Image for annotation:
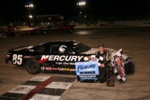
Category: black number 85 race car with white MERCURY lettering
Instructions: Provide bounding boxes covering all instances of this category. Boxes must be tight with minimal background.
[5,40,134,74]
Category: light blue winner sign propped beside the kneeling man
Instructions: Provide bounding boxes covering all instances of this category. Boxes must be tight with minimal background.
[75,61,99,82]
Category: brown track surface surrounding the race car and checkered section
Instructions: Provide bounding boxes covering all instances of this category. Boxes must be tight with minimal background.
[0,26,150,100]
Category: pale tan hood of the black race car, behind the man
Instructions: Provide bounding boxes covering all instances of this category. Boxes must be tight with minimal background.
[81,48,128,59]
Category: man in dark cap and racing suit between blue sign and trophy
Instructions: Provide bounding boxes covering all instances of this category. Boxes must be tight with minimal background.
[96,44,111,83]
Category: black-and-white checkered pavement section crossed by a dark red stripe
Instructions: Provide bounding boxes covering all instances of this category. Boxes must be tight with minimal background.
[0,76,76,100]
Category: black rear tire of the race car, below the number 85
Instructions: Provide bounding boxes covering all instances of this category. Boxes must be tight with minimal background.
[24,59,41,74]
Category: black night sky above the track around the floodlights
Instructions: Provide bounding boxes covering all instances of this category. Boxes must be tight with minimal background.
[0,0,150,20]
